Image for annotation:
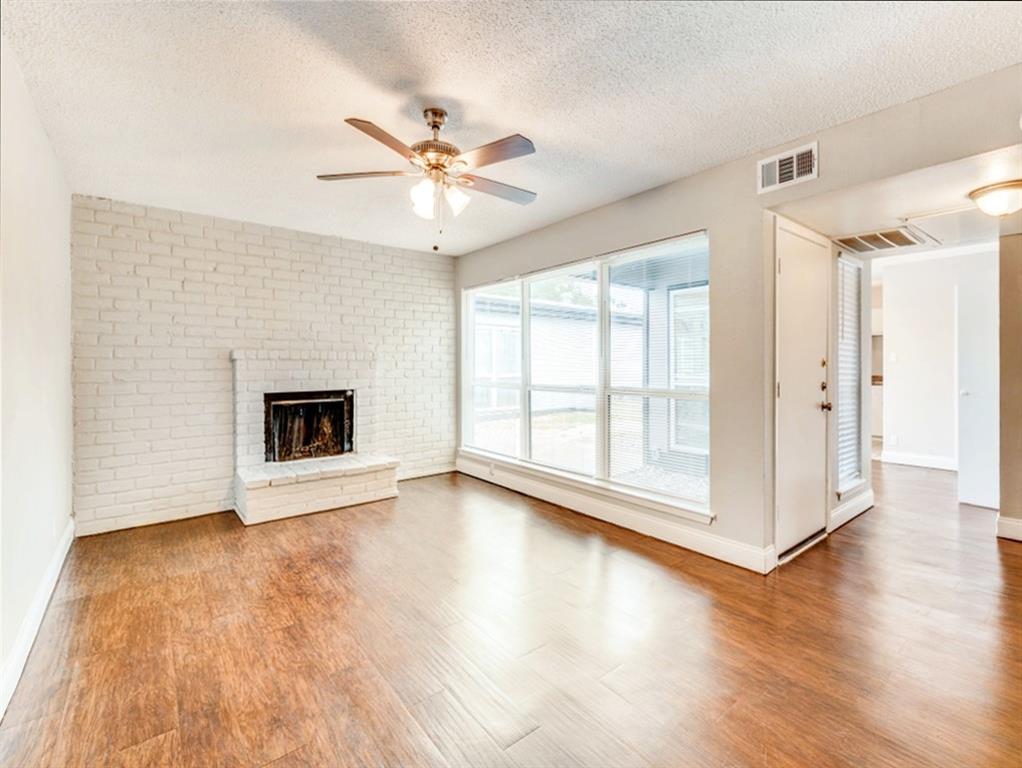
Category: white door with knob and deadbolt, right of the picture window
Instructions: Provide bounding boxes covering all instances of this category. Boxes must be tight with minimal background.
[775,217,832,554]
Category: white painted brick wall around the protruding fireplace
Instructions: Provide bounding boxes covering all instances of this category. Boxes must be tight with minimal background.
[72,195,456,531]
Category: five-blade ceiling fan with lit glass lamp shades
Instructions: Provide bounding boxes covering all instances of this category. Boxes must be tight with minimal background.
[316,106,536,232]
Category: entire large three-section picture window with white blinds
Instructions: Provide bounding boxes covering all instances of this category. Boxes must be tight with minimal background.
[462,233,710,506]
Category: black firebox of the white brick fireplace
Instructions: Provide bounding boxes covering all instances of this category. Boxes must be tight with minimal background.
[263,390,355,461]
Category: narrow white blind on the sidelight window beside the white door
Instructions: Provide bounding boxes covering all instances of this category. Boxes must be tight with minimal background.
[837,256,863,491]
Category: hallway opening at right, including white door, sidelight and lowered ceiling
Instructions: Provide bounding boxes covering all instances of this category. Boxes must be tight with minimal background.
[772,144,1022,562]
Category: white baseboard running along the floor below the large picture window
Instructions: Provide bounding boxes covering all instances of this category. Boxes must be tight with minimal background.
[458,454,777,574]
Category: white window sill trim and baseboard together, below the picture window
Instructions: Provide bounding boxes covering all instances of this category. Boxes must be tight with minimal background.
[458,449,777,574]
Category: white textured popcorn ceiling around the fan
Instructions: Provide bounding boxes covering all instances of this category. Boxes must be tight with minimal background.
[2,0,1022,254]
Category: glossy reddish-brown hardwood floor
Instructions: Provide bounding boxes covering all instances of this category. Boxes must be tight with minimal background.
[0,464,1022,768]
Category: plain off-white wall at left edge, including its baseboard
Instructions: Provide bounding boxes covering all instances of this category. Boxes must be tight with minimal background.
[0,38,72,712]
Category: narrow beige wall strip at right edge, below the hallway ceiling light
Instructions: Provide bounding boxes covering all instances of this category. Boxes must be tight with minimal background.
[1001,224,1022,518]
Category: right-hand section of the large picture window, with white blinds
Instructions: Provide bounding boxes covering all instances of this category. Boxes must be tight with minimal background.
[607,240,709,504]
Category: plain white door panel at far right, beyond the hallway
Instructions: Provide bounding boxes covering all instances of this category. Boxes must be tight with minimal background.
[957,254,1001,509]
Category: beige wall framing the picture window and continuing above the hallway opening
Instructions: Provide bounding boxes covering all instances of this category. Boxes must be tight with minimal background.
[458,65,1022,546]
